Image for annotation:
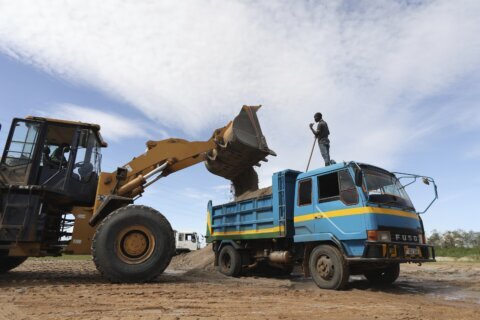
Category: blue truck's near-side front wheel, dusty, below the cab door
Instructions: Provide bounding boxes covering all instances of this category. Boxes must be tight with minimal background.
[308,245,350,290]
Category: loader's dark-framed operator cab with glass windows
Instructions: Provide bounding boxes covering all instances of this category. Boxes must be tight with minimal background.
[0,117,106,207]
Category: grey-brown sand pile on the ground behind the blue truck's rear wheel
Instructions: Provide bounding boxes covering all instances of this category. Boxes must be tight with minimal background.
[168,245,215,271]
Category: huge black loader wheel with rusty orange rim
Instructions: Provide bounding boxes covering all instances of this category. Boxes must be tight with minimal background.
[92,205,175,283]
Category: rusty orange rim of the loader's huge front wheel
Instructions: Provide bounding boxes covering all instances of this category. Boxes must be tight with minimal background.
[116,225,155,264]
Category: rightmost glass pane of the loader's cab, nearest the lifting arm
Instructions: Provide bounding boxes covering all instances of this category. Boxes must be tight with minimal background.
[72,129,101,183]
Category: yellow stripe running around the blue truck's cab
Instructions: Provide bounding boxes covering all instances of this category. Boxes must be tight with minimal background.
[293,207,418,222]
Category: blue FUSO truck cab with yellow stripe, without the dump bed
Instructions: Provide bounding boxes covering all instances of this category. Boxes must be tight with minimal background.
[294,162,434,263]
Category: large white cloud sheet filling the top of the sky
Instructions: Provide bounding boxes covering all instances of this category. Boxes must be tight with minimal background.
[0,0,480,181]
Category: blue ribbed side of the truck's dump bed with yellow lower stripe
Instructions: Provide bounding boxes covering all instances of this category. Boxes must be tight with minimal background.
[207,170,298,242]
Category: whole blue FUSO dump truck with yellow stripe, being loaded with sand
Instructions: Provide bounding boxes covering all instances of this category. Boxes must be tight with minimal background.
[207,162,438,290]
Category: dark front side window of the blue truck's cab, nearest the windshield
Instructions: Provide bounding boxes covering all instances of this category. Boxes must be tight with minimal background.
[317,170,358,205]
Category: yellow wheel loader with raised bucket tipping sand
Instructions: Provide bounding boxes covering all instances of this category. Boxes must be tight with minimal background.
[0,106,275,282]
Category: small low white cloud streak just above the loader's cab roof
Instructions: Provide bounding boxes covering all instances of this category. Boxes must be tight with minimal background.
[46,104,149,141]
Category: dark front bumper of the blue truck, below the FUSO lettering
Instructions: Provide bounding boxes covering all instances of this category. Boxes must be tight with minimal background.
[347,241,435,263]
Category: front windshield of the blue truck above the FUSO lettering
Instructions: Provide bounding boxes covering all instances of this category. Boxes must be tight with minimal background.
[364,169,415,210]
